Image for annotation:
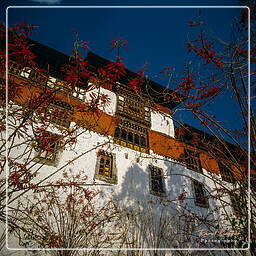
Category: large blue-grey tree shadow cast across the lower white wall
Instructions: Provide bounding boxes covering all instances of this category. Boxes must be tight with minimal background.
[110,161,232,250]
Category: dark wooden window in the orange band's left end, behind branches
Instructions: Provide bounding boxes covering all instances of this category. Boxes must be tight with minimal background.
[47,100,73,128]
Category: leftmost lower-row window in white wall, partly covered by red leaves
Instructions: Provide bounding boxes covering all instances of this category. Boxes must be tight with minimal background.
[33,131,61,166]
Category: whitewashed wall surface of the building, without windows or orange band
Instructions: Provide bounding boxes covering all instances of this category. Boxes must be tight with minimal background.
[3,88,236,252]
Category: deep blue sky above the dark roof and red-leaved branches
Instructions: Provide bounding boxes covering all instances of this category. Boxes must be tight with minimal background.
[0,0,248,144]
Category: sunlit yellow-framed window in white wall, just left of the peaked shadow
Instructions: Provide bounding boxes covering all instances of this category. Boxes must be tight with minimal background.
[95,150,117,184]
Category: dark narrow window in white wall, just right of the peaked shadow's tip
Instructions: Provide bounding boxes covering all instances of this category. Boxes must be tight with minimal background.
[149,165,166,196]
